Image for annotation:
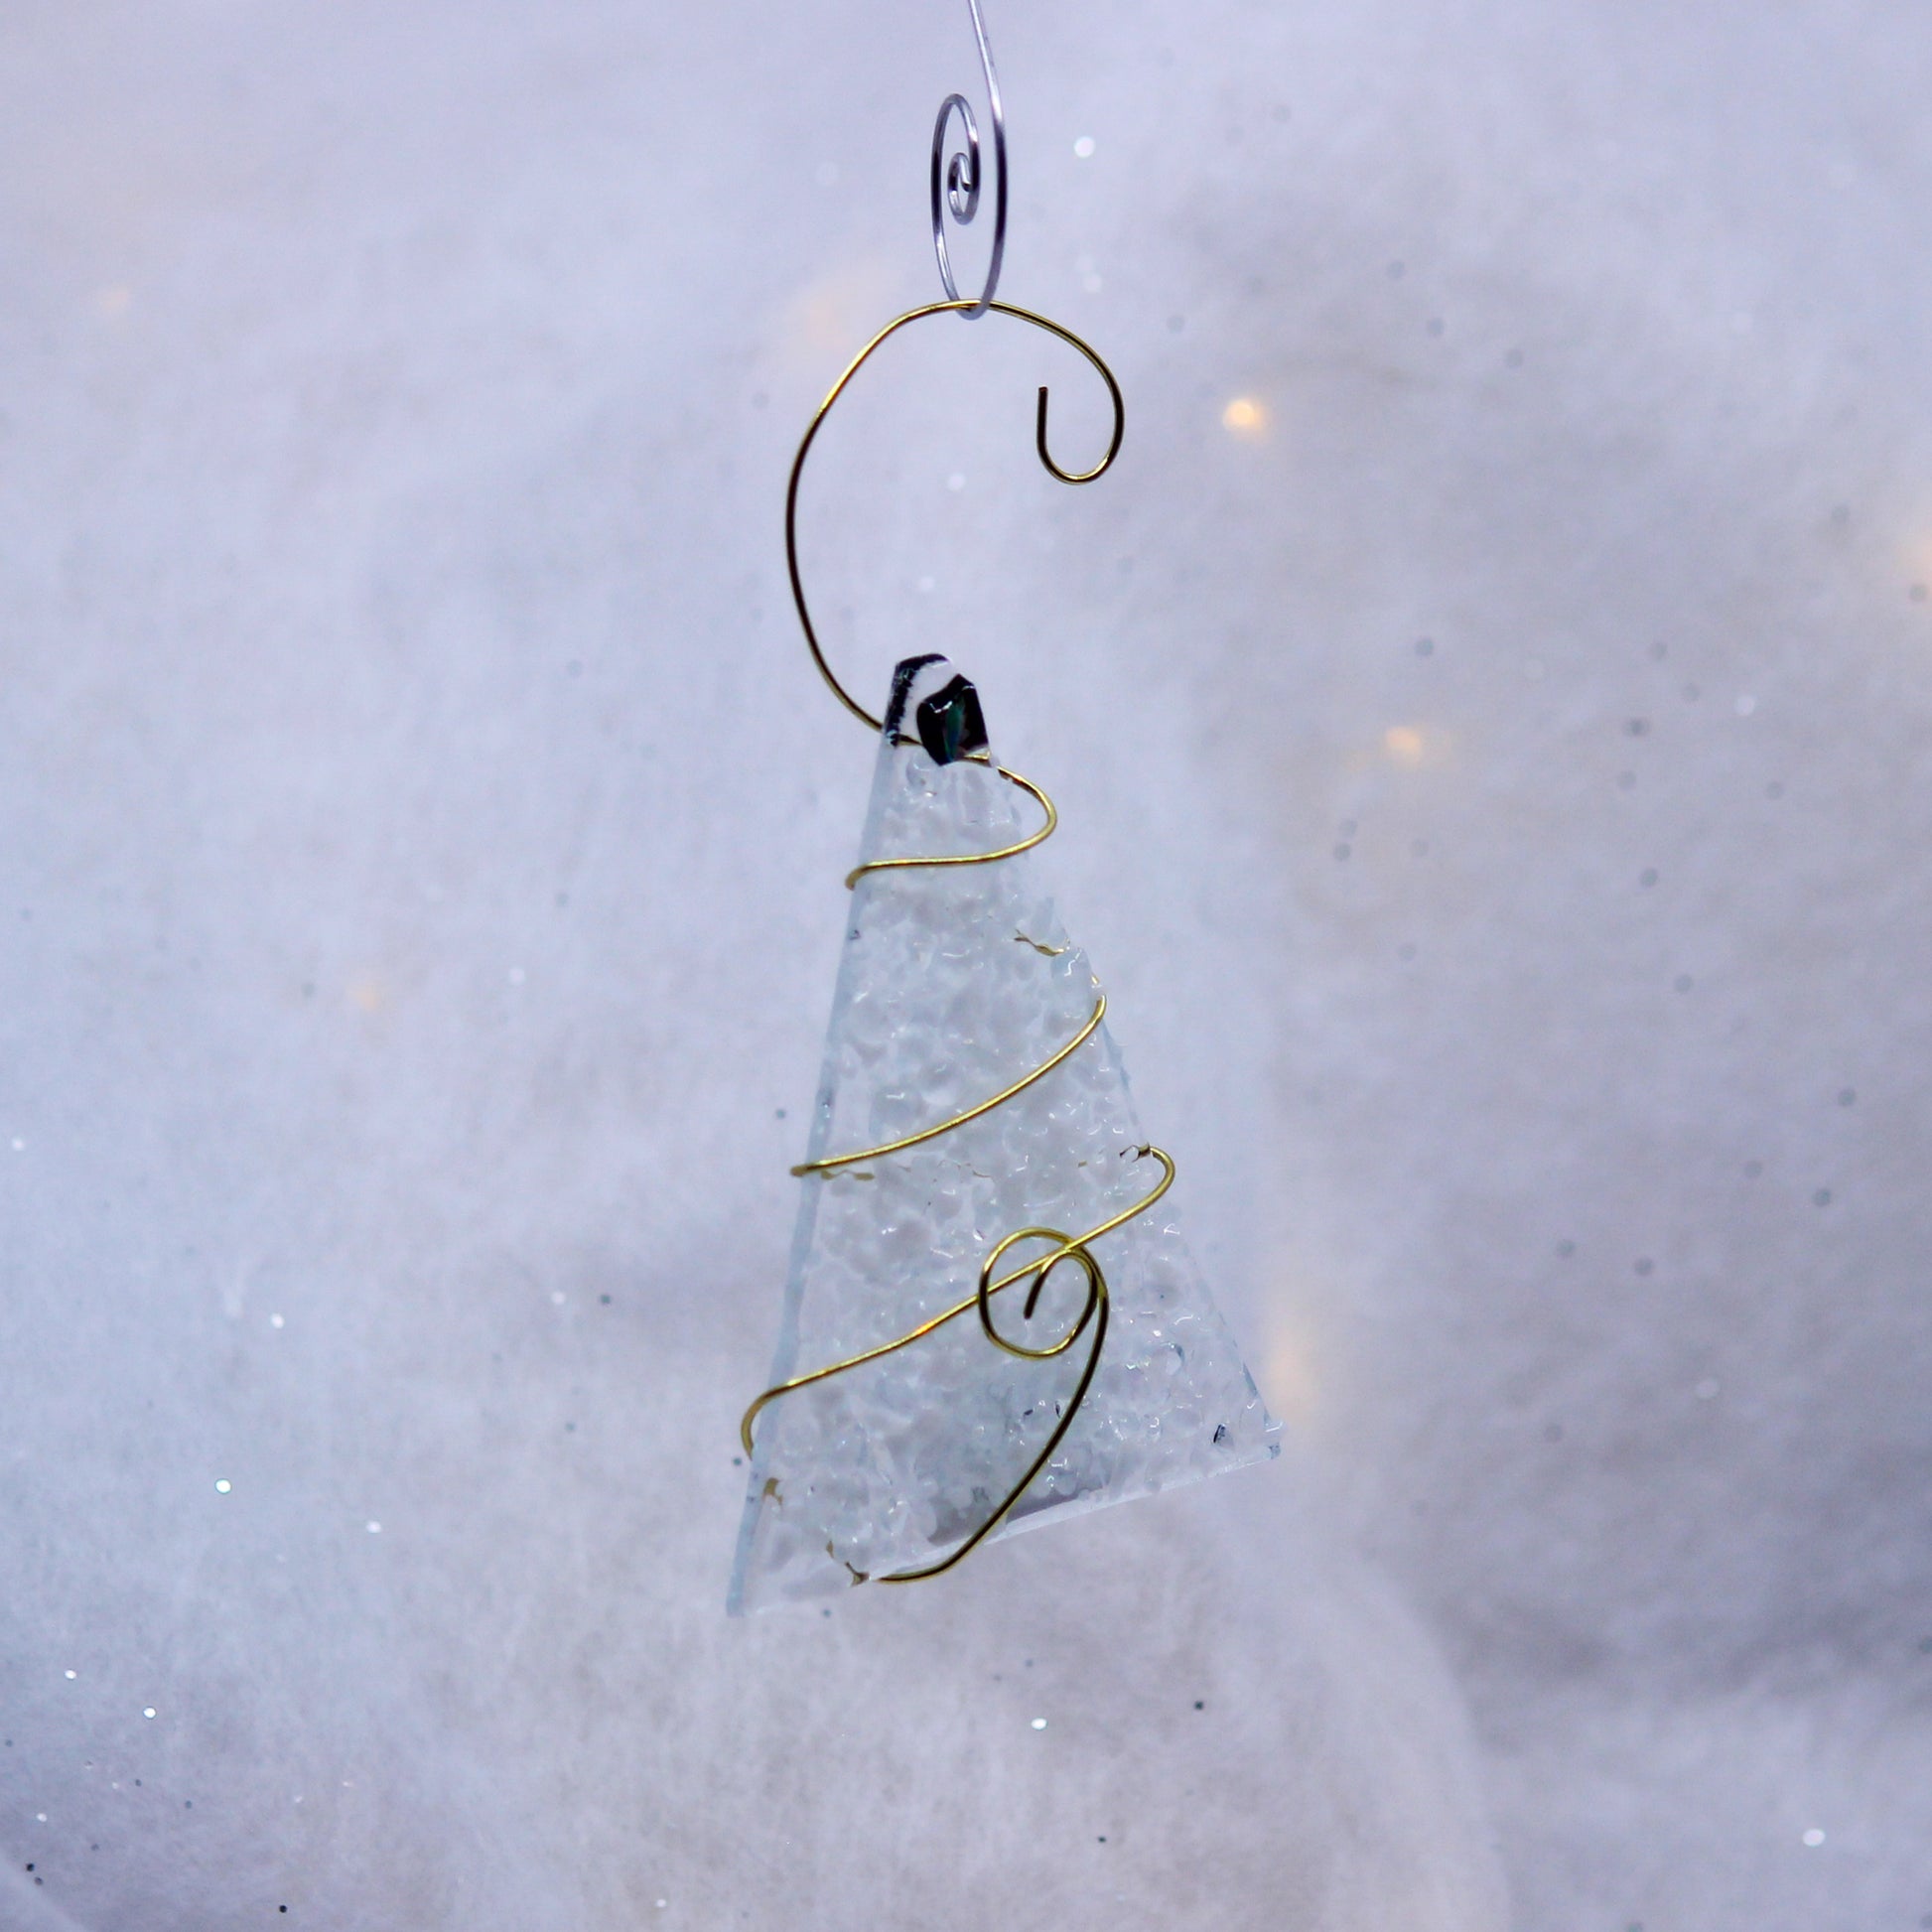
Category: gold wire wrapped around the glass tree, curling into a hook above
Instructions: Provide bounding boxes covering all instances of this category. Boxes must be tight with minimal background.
[738,289,1174,1583]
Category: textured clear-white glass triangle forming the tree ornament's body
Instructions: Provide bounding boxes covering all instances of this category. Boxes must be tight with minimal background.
[731,659,1279,1611]
